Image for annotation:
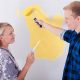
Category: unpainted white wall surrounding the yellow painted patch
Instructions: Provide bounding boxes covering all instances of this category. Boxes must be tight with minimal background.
[0,0,79,80]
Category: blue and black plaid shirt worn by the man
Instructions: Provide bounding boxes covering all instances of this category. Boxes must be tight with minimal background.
[62,30,80,80]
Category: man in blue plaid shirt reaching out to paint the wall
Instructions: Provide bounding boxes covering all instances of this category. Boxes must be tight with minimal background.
[37,1,80,80]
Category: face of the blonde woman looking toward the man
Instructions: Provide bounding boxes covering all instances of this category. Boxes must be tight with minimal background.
[1,26,15,44]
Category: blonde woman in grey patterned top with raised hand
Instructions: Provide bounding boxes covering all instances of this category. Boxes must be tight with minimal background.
[0,23,34,80]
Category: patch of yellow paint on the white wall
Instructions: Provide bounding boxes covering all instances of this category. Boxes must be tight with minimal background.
[24,6,64,60]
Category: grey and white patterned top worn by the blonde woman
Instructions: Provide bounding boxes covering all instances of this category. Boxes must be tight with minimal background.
[0,48,20,80]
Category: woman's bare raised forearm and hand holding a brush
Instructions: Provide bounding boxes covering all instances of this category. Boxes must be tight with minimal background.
[17,52,34,80]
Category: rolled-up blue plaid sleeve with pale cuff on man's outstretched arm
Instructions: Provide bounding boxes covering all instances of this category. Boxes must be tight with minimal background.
[61,30,73,43]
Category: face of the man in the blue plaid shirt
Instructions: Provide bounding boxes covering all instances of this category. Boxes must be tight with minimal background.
[64,10,77,30]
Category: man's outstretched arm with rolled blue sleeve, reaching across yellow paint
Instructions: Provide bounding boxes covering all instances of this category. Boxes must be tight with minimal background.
[36,19,74,43]
